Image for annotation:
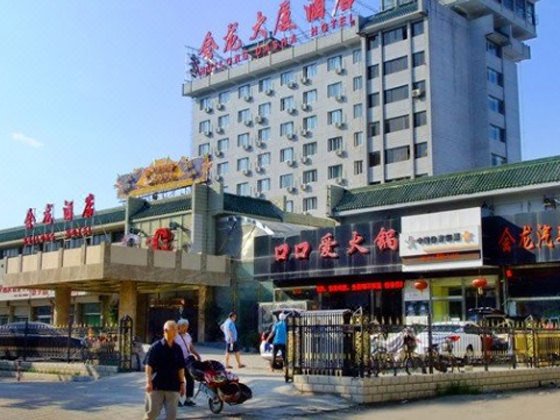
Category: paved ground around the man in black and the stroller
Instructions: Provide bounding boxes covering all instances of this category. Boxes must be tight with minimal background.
[0,346,352,420]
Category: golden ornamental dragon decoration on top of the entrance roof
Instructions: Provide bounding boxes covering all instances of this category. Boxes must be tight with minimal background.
[115,155,212,199]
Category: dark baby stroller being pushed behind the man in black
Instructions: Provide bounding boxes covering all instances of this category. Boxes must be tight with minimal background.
[187,360,253,414]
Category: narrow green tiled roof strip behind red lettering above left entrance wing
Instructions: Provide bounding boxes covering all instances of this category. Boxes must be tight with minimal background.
[0,207,125,243]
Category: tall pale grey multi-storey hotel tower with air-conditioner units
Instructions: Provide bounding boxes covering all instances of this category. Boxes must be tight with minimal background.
[183,0,537,216]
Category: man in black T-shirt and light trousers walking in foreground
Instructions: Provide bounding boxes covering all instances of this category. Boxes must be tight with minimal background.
[144,321,185,420]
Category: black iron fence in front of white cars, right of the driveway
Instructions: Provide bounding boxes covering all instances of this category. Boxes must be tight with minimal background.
[285,310,560,381]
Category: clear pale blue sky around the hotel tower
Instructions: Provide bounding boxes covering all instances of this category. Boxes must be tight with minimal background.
[0,0,560,229]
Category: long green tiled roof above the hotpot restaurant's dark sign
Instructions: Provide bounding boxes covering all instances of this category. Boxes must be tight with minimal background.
[334,156,560,213]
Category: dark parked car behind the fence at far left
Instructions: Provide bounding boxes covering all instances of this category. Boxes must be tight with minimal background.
[0,321,86,360]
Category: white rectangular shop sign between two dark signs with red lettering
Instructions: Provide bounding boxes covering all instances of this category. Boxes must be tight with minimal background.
[400,207,482,271]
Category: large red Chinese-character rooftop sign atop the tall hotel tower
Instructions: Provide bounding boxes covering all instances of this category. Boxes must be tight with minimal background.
[189,0,356,77]
